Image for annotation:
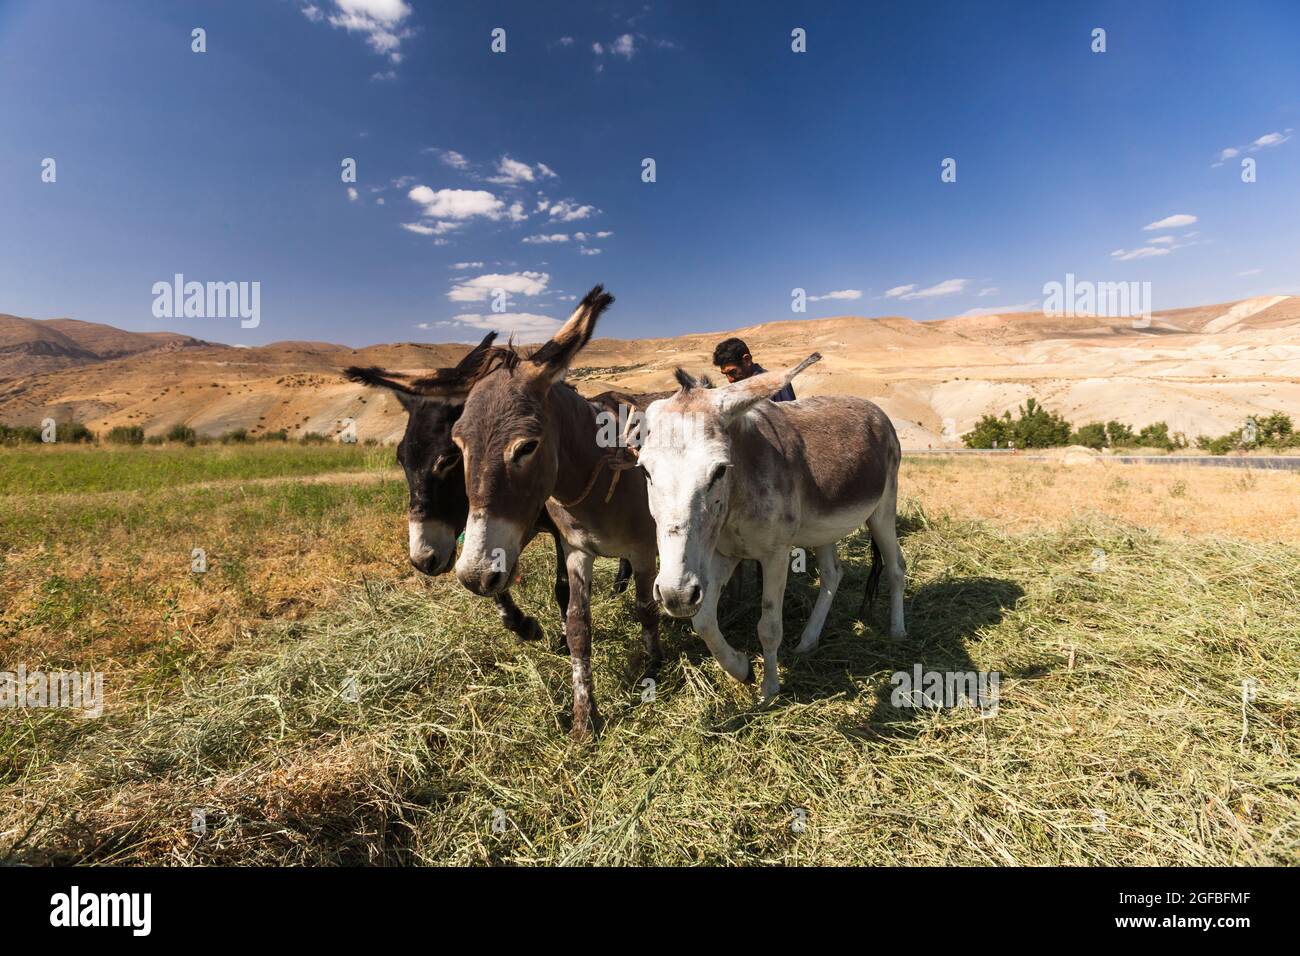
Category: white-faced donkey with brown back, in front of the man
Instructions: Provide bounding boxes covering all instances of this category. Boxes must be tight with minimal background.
[638,354,906,697]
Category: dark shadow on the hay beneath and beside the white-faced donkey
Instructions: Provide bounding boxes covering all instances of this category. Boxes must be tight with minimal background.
[644,515,1028,739]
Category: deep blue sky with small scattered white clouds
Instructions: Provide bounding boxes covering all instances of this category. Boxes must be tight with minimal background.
[0,0,1300,346]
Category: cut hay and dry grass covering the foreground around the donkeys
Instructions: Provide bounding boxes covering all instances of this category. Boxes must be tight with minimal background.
[0,447,1300,865]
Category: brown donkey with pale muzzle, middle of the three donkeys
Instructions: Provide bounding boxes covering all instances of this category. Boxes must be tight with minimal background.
[379,286,662,739]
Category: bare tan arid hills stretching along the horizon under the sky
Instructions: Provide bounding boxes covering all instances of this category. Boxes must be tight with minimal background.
[0,295,1300,449]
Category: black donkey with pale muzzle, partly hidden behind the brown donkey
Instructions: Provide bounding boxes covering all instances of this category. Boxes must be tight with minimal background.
[345,332,632,640]
